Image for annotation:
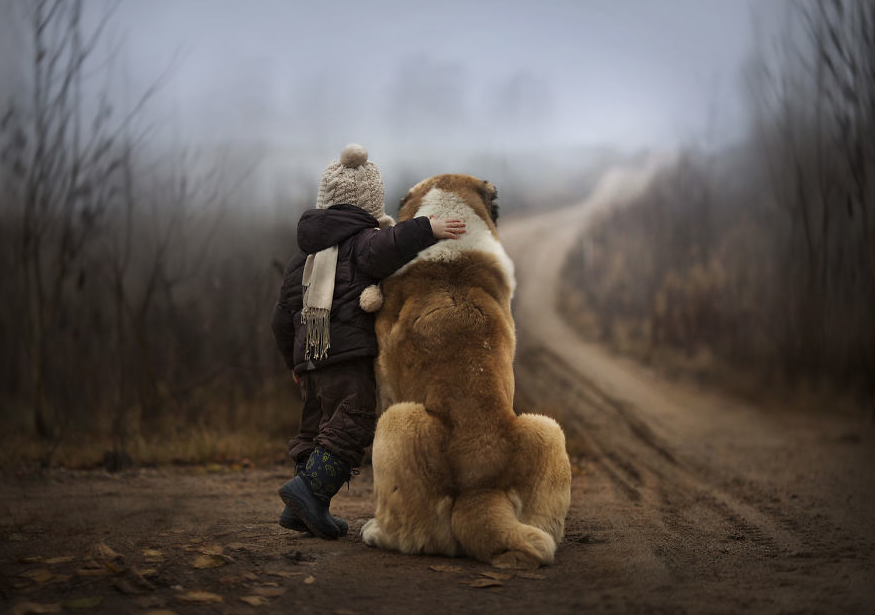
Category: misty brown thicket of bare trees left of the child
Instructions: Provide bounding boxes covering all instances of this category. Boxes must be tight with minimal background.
[0,0,306,462]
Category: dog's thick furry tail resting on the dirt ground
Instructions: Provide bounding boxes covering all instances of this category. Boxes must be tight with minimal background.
[452,489,556,569]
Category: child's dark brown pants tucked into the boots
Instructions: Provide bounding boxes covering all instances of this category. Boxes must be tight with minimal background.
[289,357,377,467]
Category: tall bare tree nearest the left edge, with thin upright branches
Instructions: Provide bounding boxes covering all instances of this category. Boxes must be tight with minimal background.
[10,0,126,437]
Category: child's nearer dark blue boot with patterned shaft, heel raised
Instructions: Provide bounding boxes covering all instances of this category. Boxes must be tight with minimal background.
[279,446,351,539]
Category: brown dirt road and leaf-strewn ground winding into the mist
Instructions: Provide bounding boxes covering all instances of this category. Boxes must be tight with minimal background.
[0,168,875,615]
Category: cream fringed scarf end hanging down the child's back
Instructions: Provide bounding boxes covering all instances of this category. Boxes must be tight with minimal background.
[301,246,337,361]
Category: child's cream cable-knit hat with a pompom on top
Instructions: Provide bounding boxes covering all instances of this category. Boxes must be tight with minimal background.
[316,143,393,227]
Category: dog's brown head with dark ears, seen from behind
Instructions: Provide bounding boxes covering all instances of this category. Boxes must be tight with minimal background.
[398,174,498,236]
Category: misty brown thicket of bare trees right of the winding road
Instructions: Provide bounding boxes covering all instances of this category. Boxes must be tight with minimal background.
[564,0,875,400]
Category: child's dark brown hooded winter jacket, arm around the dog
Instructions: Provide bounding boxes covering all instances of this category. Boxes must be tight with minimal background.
[272,205,437,374]
